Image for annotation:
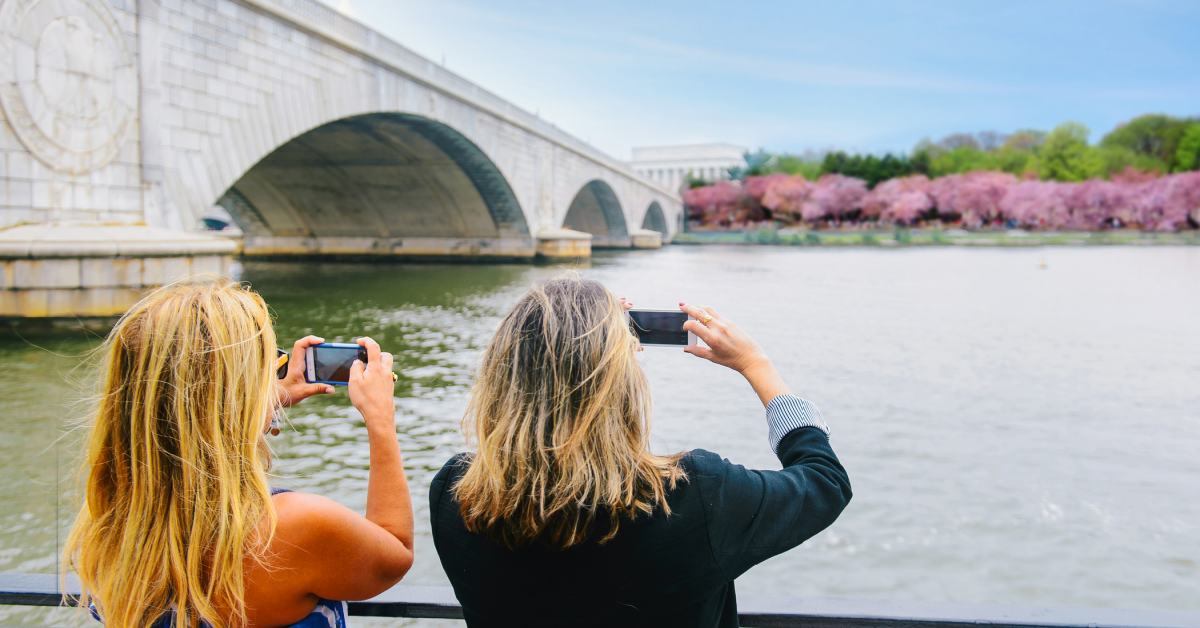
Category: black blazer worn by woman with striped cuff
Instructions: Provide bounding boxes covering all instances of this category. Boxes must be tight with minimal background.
[430,427,851,628]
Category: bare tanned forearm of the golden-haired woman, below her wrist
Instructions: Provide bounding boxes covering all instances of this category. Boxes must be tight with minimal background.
[367,425,413,550]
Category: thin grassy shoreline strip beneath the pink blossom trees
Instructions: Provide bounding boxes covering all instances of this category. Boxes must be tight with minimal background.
[671,229,1200,249]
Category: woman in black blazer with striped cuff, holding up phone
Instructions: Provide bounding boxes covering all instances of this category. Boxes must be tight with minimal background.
[430,275,851,628]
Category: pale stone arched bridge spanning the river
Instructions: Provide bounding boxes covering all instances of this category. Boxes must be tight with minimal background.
[0,0,683,262]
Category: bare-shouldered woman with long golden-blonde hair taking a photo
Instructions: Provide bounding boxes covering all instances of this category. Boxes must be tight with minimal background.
[65,280,413,628]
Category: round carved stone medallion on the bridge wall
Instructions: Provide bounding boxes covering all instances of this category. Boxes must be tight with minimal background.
[0,0,137,174]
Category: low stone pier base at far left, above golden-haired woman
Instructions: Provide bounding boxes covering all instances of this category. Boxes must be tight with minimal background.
[0,223,236,331]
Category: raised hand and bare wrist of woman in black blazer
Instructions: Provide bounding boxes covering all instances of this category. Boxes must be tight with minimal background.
[679,303,788,406]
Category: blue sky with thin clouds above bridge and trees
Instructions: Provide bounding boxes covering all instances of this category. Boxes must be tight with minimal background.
[326,0,1200,159]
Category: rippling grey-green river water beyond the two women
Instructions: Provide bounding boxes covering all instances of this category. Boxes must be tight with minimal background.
[0,246,1200,626]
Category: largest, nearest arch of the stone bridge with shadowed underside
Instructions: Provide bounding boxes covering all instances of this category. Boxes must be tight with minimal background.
[220,113,532,256]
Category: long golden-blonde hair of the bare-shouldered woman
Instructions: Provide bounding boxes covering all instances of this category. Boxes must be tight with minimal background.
[64,279,278,628]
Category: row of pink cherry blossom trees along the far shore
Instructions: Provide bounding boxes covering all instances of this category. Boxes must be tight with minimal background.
[684,169,1200,231]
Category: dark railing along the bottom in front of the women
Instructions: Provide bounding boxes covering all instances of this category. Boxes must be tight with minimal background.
[0,573,1200,628]
